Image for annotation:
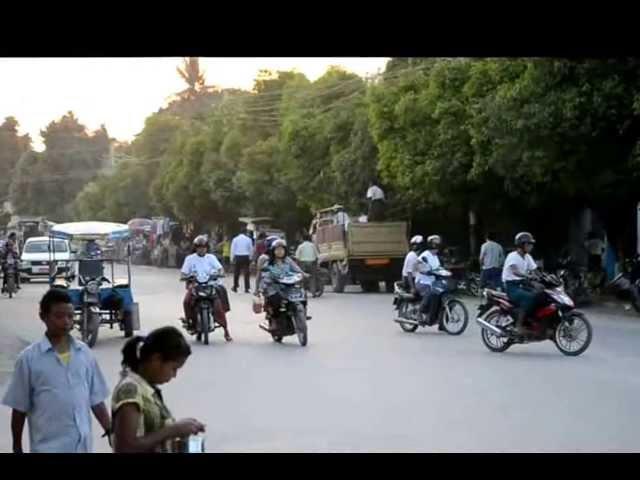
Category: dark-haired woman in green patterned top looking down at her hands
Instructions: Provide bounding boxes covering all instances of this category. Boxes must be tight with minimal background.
[111,327,204,453]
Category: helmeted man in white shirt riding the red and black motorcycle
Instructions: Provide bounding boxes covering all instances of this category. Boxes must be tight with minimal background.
[502,232,538,331]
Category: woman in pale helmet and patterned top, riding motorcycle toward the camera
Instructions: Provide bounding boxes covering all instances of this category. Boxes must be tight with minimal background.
[260,238,310,330]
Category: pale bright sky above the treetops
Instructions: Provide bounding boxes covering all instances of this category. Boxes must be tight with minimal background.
[0,57,387,150]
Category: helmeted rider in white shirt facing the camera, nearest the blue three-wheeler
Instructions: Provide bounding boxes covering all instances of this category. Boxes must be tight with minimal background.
[180,235,233,342]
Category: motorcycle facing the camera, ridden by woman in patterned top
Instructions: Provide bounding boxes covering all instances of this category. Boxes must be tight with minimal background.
[259,270,310,347]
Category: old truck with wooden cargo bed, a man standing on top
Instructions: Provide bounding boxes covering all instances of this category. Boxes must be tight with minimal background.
[309,205,409,293]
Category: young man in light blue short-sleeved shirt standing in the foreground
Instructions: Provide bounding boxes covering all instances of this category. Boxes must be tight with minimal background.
[2,289,111,453]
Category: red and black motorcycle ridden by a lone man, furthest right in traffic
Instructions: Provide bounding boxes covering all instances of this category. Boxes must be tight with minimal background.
[476,272,593,356]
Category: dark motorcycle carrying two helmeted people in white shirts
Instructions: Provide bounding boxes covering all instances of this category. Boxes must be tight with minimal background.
[393,269,469,335]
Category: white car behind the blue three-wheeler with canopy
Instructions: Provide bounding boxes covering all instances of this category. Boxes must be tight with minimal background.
[20,237,75,282]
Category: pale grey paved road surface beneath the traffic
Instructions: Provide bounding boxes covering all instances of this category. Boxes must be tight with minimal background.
[0,267,640,452]
